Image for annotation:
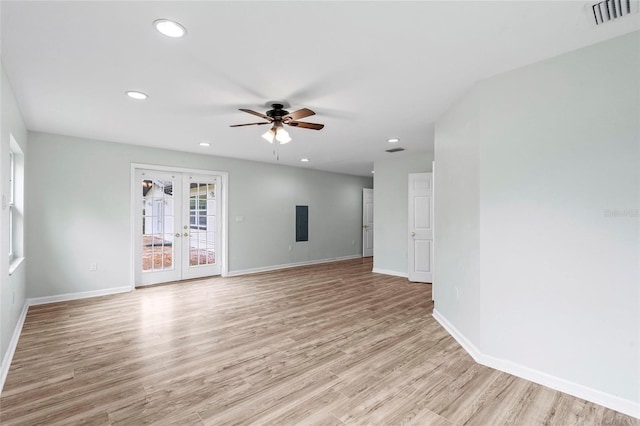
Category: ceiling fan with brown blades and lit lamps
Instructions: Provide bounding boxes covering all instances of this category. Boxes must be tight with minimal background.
[230,103,324,145]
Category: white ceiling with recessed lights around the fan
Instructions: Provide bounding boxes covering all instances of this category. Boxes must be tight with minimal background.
[1,0,640,176]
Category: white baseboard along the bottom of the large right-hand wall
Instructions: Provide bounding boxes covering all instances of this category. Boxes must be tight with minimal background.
[433,309,640,419]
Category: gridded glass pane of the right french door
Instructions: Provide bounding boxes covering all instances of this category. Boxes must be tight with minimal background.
[189,182,216,267]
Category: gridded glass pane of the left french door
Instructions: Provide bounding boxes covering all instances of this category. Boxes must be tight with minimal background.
[141,179,174,272]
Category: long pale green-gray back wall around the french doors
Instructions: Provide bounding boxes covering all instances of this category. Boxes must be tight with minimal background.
[26,133,371,297]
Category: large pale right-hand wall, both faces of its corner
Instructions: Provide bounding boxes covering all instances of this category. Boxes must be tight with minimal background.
[434,32,640,415]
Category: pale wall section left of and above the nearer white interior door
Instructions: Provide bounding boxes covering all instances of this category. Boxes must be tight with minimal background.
[373,151,433,277]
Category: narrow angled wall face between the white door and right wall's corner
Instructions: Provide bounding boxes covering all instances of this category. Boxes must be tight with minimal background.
[433,88,482,345]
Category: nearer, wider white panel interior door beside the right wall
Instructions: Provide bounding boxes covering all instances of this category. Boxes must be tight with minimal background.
[408,173,433,283]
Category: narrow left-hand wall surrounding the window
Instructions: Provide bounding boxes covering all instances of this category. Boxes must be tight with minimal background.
[0,67,27,374]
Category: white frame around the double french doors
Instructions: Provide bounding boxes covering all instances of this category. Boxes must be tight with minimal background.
[129,163,229,290]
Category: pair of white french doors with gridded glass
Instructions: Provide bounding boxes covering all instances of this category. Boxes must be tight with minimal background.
[133,169,222,286]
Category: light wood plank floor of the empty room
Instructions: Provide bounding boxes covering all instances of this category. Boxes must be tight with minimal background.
[0,259,640,426]
